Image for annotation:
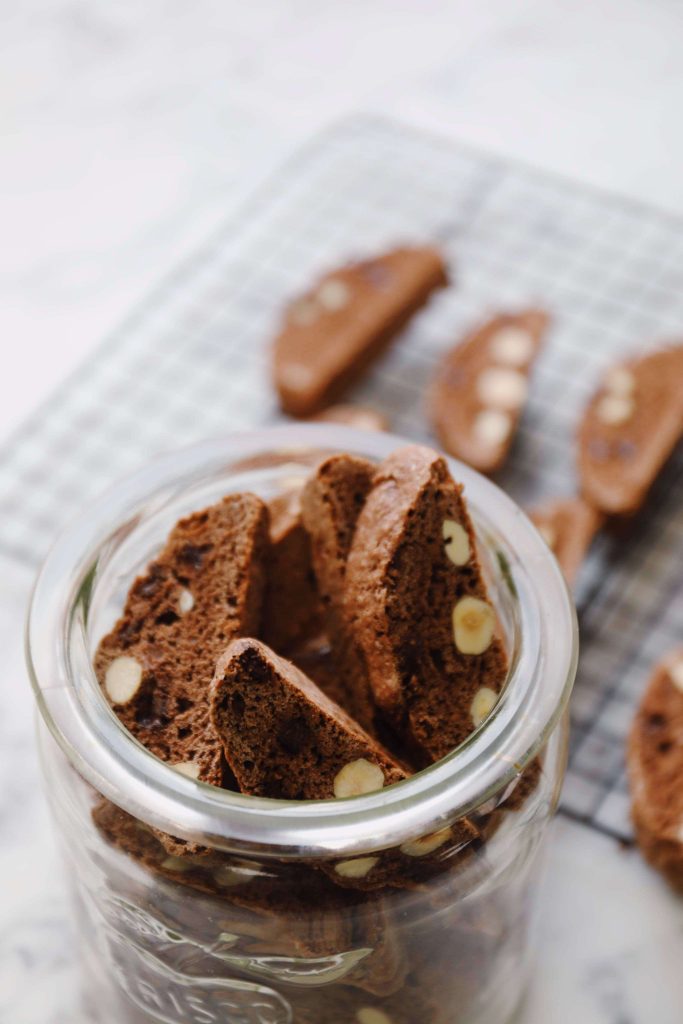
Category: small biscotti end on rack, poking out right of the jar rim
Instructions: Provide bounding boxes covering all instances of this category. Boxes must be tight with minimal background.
[528,498,603,586]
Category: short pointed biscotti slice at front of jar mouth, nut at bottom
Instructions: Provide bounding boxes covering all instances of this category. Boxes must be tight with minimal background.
[211,639,405,800]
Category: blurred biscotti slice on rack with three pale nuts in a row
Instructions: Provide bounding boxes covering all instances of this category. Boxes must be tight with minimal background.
[430,309,549,473]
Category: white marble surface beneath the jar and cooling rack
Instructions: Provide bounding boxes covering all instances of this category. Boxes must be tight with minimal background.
[0,0,683,1024]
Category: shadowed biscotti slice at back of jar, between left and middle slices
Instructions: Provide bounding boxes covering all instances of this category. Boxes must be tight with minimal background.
[261,488,322,654]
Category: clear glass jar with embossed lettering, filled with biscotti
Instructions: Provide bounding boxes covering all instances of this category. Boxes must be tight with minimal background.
[28,425,577,1024]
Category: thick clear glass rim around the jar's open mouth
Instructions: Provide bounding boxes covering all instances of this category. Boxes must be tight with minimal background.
[27,424,578,857]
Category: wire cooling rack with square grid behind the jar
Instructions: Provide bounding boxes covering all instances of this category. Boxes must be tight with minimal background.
[0,117,683,839]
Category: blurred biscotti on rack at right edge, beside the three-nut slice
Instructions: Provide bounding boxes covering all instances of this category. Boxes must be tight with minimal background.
[579,346,683,515]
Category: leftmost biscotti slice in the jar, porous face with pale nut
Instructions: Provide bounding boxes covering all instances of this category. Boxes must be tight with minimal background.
[94,494,268,785]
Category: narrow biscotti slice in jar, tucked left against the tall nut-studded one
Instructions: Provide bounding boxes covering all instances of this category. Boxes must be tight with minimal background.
[301,455,376,734]
